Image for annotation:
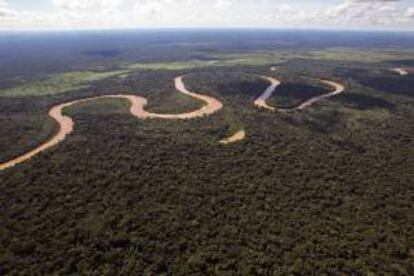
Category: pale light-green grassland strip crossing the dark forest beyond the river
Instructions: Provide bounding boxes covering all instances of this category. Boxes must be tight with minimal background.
[0,47,414,97]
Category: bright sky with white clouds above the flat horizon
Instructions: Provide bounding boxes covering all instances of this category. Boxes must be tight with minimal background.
[0,0,414,31]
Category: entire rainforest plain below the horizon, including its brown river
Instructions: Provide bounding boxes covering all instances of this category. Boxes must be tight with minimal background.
[0,29,414,275]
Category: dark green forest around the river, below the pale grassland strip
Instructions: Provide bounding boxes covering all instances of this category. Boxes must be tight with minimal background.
[0,51,414,275]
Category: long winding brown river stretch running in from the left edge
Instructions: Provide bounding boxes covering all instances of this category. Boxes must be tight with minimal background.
[0,76,223,170]
